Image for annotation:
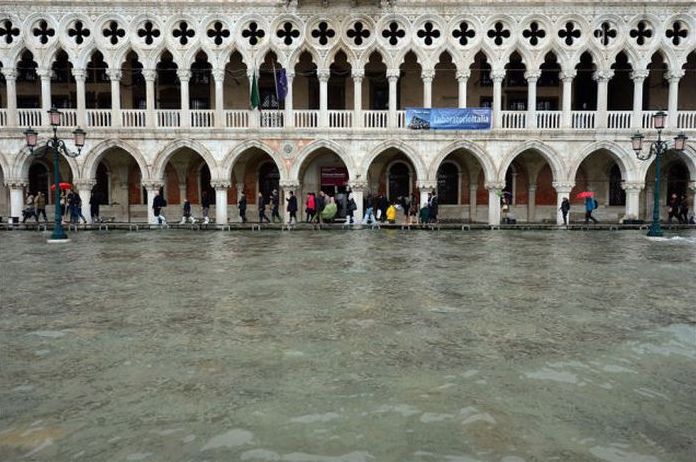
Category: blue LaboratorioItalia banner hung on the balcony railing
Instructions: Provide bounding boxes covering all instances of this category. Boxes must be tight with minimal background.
[406,108,492,130]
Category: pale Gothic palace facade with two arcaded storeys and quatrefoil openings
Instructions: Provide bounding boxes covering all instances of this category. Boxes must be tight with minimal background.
[0,0,696,224]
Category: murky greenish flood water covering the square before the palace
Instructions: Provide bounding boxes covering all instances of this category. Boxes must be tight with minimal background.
[0,230,696,462]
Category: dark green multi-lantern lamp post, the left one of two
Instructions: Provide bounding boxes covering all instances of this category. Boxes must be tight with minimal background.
[24,107,86,242]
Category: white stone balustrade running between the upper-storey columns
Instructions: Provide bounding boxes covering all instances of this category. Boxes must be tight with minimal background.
[0,109,696,131]
